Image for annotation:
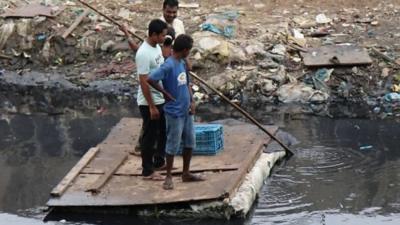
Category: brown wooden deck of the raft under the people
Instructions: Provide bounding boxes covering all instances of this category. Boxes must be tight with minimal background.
[47,118,277,207]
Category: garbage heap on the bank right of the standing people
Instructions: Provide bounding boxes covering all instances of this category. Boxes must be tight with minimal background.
[188,3,400,118]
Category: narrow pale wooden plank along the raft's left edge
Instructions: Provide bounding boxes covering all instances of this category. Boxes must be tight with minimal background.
[50,147,99,197]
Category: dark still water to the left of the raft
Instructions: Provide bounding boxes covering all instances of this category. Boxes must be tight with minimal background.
[0,115,119,213]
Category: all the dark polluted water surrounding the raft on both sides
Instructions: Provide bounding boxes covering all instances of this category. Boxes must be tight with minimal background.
[0,113,400,225]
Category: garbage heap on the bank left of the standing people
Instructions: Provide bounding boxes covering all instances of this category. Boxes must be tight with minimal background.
[0,0,152,75]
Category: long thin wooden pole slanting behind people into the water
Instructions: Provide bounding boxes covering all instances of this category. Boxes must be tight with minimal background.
[78,0,294,157]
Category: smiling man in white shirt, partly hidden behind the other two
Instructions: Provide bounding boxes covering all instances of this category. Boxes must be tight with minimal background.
[160,0,185,37]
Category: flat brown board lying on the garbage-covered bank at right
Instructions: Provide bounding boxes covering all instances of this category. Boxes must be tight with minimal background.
[301,45,372,66]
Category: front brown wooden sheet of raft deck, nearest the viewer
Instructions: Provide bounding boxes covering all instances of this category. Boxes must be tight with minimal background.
[47,171,236,206]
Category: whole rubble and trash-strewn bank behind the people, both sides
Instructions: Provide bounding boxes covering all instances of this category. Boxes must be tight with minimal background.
[0,0,400,118]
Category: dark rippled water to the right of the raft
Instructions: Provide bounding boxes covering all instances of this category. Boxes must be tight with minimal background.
[250,117,400,225]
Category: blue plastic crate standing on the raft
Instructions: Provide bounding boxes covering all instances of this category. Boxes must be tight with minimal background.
[179,124,224,155]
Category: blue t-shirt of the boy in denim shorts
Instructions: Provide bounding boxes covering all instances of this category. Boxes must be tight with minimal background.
[150,57,190,117]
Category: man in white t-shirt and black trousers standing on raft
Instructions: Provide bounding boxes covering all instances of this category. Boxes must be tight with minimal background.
[135,19,167,180]
